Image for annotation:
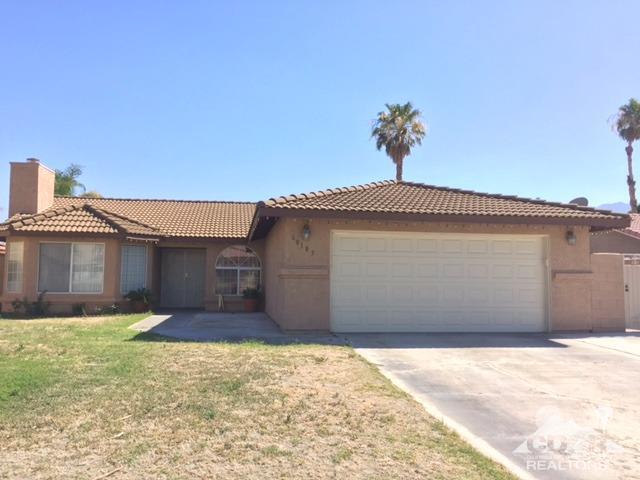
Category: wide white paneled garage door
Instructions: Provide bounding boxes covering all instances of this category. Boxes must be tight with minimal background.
[331,231,547,332]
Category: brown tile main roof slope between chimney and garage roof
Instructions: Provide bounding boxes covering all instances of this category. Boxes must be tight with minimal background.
[53,197,255,238]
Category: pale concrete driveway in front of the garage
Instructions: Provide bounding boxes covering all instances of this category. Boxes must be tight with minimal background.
[347,333,640,479]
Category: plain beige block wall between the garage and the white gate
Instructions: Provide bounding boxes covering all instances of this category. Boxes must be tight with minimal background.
[591,253,625,331]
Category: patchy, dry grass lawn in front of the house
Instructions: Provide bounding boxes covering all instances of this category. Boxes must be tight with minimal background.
[0,316,511,479]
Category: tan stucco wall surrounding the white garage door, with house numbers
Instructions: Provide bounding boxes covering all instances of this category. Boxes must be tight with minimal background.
[265,218,608,331]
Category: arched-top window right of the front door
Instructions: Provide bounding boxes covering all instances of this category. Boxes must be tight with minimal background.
[216,245,262,295]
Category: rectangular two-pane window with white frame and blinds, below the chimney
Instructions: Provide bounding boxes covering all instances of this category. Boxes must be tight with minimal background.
[38,243,104,293]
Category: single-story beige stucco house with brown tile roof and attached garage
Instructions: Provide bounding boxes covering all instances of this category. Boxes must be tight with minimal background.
[0,160,629,332]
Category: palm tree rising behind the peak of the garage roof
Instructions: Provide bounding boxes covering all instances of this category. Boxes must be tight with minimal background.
[371,102,427,182]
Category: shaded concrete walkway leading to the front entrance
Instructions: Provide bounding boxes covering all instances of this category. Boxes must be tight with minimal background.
[129,311,345,345]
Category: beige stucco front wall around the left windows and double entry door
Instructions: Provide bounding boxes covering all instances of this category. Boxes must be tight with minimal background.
[0,235,265,313]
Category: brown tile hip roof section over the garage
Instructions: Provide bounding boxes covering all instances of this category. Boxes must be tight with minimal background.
[258,180,628,224]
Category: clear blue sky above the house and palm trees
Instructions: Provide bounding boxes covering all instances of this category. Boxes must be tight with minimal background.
[0,0,640,213]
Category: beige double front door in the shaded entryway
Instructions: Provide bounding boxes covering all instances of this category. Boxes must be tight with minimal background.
[160,248,206,308]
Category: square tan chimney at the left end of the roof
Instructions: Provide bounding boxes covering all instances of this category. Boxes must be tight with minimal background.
[9,158,56,217]
